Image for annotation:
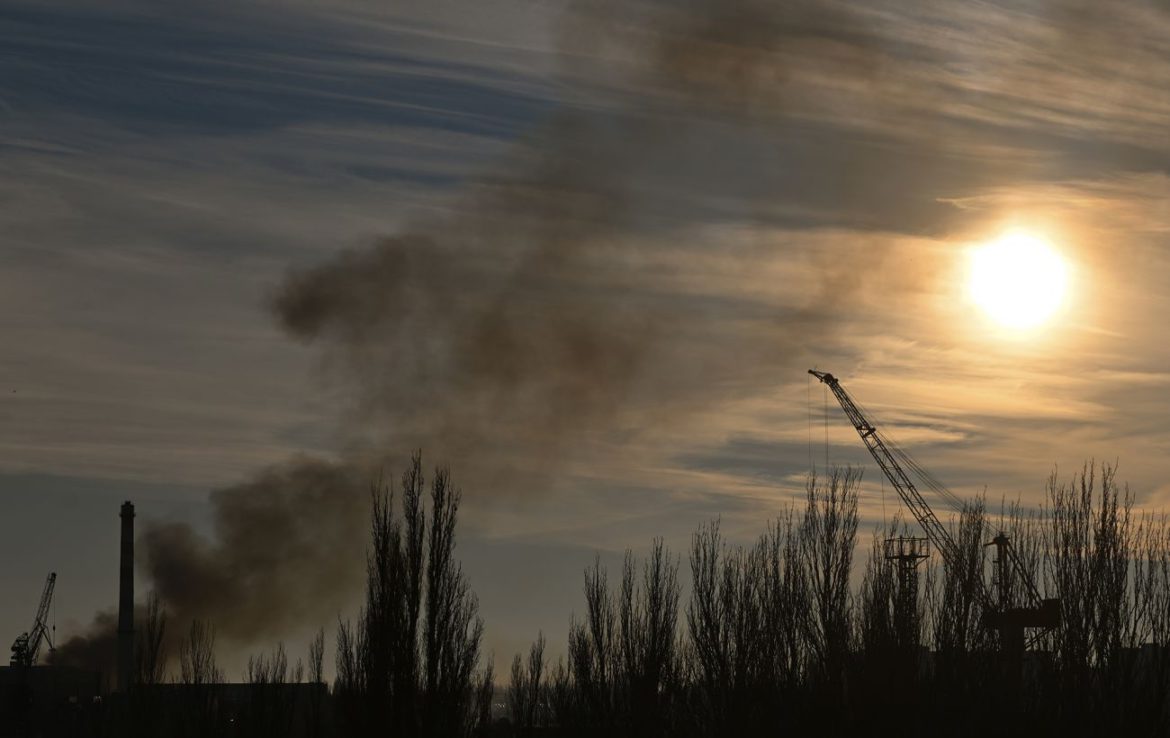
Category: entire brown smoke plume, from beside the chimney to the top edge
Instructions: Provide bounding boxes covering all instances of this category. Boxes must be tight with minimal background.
[62,0,1006,662]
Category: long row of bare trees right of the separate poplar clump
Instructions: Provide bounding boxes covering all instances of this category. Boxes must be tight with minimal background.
[501,464,1170,737]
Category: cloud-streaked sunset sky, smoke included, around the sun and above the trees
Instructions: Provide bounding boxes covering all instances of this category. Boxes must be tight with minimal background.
[0,0,1170,678]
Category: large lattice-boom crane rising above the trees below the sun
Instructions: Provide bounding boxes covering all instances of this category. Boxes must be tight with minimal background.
[808,370,1060,654]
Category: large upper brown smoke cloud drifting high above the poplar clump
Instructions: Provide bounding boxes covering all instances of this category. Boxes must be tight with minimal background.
[273,1,921,477]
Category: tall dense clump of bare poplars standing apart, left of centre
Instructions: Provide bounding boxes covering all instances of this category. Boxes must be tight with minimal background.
[338,454,483,737]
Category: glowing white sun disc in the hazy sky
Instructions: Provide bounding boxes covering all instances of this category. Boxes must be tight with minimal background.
[969,233,1068,330]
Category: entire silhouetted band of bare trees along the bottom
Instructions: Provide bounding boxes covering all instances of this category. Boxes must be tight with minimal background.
[59,456,1170,738]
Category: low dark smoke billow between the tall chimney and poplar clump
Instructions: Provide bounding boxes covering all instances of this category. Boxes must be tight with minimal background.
[55,457,365,674]
